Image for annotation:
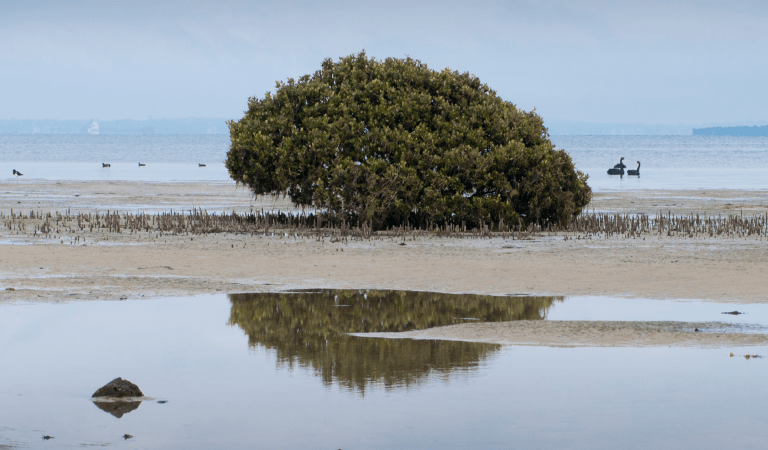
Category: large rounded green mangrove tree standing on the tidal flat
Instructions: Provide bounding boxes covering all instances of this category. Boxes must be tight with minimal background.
[226,53,592,229]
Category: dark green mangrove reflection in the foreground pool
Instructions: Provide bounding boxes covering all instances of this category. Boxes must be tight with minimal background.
[229,290,562,393]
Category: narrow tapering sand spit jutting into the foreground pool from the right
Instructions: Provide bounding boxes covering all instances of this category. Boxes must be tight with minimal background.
[355,320,768,348]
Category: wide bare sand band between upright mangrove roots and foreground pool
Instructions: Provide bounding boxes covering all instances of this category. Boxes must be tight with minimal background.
[0,229,768,303]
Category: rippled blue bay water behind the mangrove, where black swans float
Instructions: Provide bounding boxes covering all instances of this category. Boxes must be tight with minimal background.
[0,134,768,191]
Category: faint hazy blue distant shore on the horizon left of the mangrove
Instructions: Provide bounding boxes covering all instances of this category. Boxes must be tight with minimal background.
[0,118,229,134]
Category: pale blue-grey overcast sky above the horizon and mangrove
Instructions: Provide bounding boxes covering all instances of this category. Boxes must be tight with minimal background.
[0,0,768,125]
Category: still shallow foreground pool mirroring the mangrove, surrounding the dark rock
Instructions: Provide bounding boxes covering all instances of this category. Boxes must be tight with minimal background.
[0,291,768,449]
